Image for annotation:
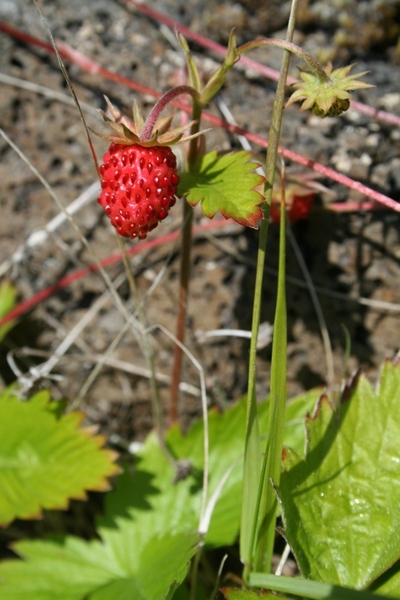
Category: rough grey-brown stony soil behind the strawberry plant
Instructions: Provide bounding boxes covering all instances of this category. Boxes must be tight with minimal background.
[0,0,400,440]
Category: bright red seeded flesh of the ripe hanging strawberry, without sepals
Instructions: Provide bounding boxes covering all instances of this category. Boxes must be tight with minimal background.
[98,142,179,240]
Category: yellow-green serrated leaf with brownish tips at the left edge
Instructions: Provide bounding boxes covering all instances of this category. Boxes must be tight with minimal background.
[0,391,119,525]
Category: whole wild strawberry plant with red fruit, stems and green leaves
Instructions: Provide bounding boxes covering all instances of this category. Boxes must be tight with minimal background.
[0,2,400,600]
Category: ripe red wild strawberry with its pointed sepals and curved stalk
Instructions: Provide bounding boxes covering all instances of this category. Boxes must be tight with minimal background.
[96,95,201,240]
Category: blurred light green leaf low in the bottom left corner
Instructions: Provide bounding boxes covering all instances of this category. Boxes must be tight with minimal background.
[0,533,198,600]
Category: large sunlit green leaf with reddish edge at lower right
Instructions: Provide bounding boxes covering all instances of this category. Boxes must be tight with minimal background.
[279,362,400,589]
